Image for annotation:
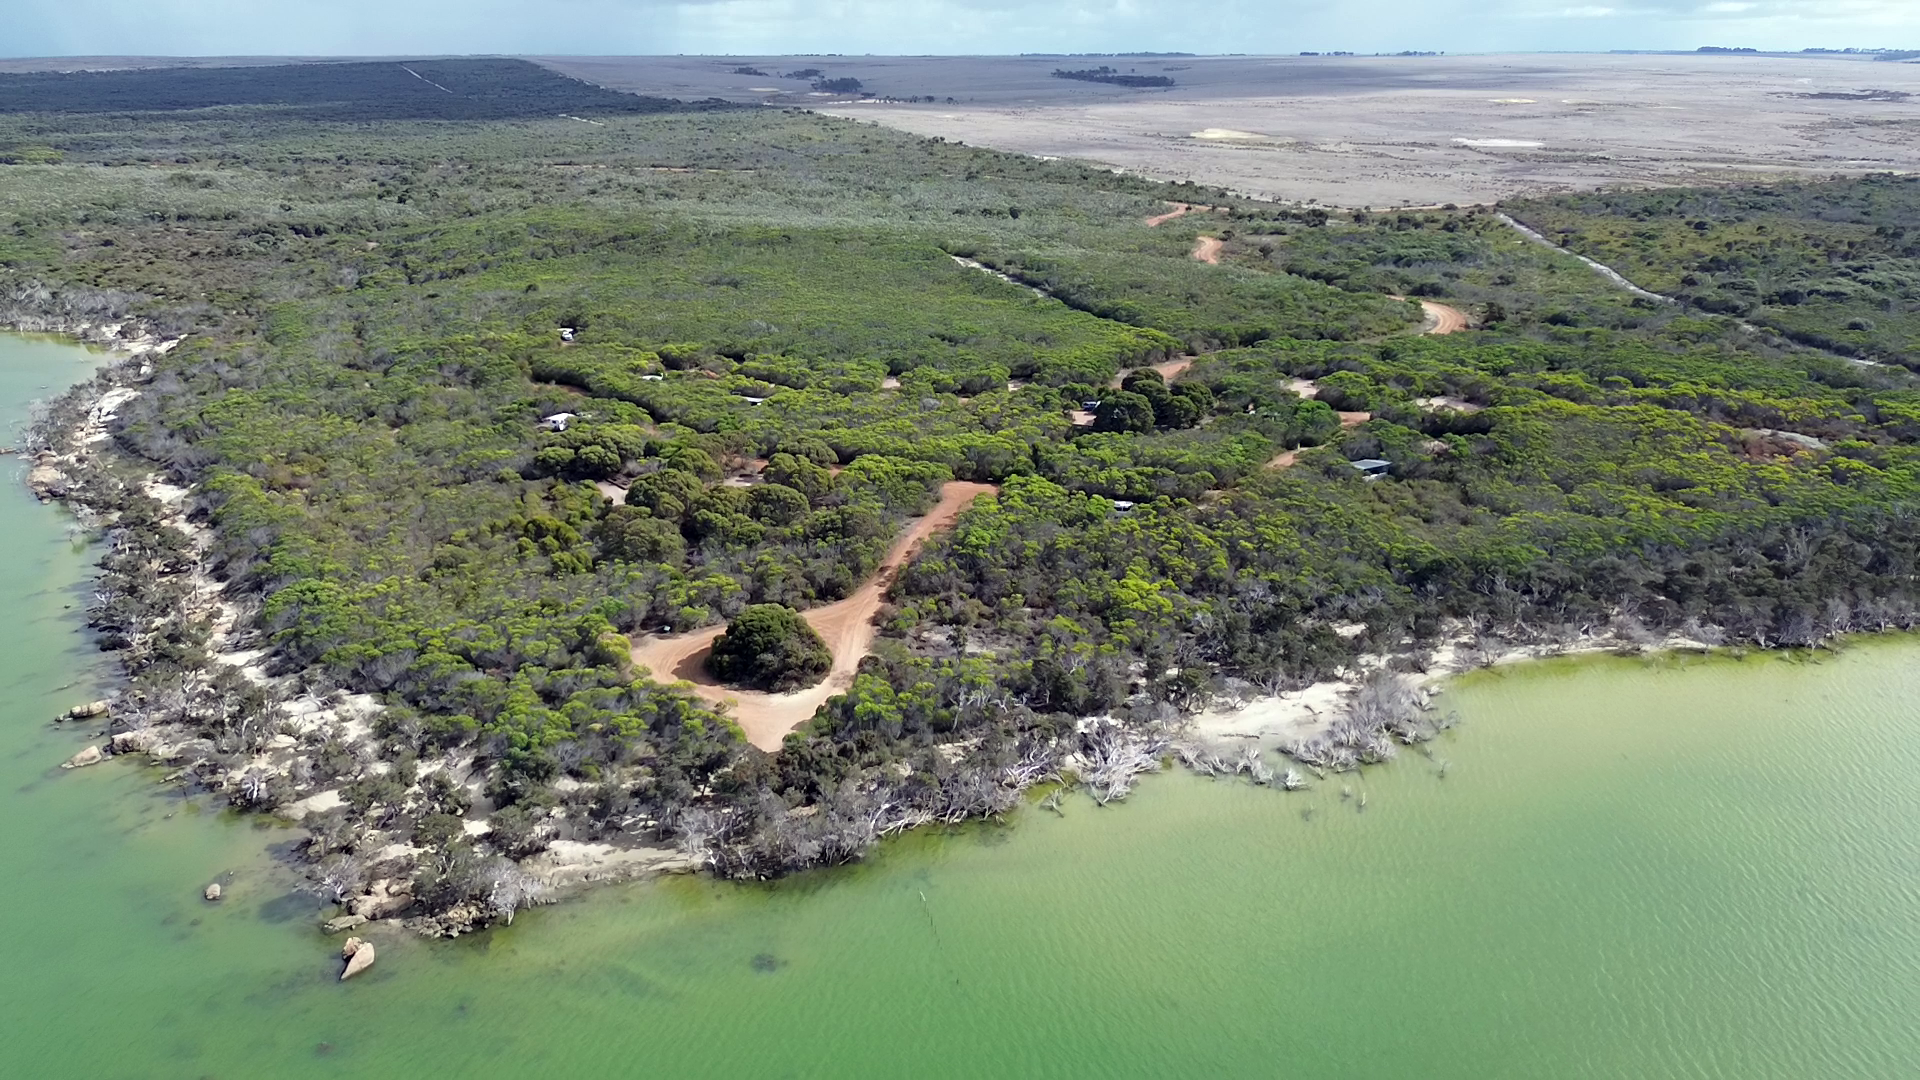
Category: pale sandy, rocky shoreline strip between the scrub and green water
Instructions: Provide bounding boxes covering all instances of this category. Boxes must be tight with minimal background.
[10,297,1896,936]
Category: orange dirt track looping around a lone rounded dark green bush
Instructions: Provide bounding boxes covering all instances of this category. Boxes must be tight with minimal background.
[632,480,996,749]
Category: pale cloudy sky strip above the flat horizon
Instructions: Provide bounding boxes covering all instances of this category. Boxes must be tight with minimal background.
[0,0,1920,56]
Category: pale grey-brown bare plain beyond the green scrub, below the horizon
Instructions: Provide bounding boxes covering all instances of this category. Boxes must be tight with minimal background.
[725,56,1920,208]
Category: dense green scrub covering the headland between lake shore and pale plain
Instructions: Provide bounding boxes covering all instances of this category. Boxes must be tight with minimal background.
[0,69,1920,903]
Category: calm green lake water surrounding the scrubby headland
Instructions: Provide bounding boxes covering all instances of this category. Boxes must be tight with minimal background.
[11,338,1920,1078]
